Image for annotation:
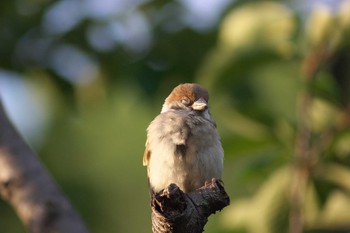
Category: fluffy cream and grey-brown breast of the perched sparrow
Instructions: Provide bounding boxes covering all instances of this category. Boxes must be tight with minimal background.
[147,110,223,192]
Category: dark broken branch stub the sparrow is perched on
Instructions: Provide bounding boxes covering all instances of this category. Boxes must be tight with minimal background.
[151,179,230,233]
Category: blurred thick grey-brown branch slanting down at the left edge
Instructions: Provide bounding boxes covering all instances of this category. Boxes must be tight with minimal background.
[0,101,88,233]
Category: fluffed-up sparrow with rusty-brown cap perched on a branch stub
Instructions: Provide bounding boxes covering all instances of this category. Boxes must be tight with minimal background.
[143,83,224,193]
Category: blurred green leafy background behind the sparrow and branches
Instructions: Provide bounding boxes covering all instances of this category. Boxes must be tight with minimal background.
[0,0,350,233]
